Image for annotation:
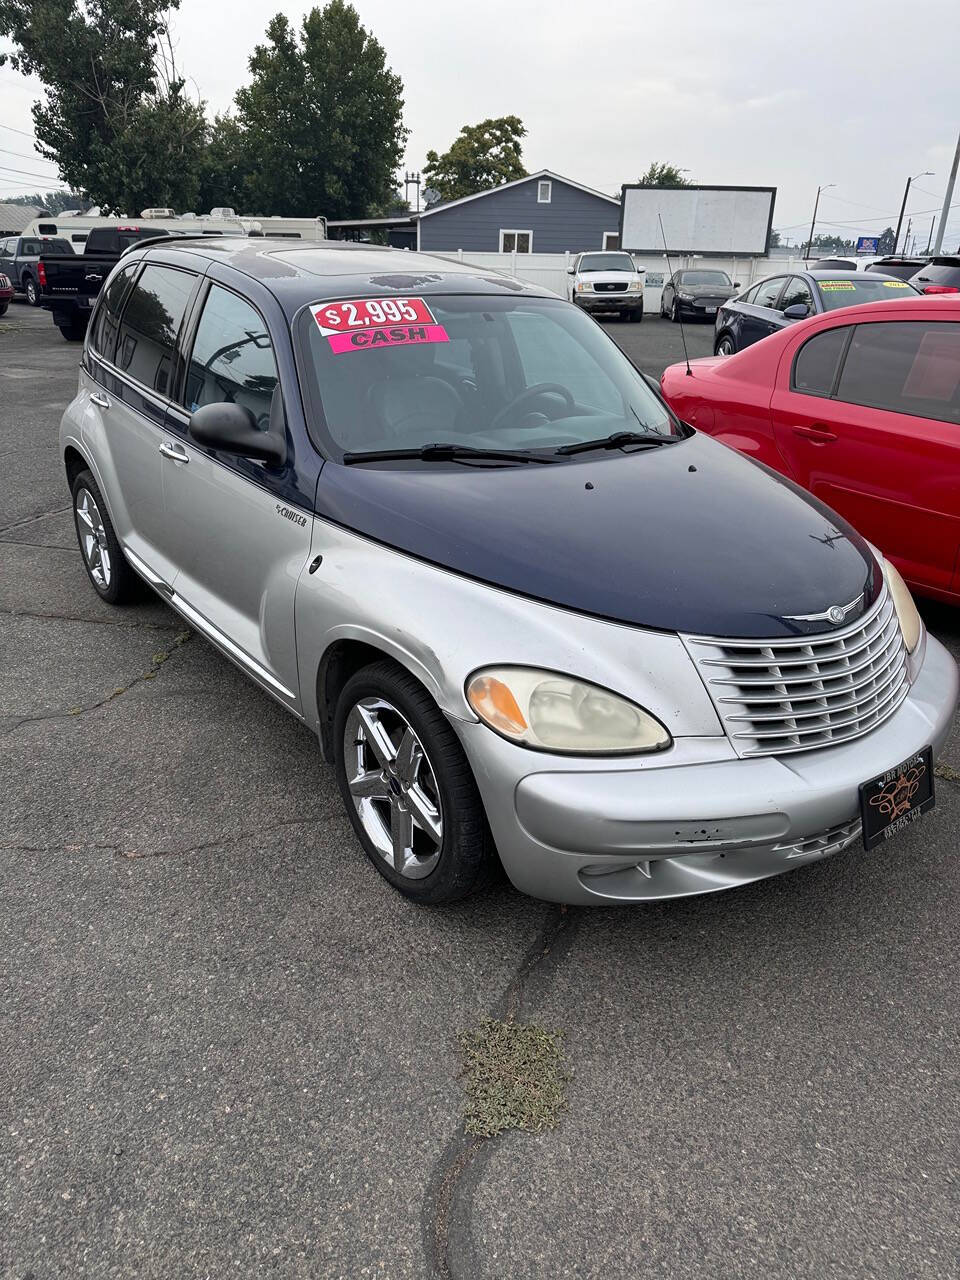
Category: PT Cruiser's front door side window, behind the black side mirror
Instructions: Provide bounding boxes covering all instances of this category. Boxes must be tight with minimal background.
[186,284,279,431]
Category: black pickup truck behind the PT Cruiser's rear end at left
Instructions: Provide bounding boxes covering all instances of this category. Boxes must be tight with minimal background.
[37,223,177,342]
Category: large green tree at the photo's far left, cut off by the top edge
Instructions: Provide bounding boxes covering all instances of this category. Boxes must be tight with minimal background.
[0,0,204,214]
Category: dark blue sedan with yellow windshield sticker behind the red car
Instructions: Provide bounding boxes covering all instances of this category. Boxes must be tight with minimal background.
[713,271,919,356]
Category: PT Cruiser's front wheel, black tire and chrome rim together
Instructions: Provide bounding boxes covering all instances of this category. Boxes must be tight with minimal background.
[334,659,495,904]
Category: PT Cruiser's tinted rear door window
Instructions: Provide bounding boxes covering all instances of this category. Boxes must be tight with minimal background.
[115,264,196,396]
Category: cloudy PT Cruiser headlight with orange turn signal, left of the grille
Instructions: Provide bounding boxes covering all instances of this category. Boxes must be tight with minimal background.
[466,667,672,755]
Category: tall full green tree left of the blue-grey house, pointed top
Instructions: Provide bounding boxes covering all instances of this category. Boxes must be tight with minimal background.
[220,0,407,218]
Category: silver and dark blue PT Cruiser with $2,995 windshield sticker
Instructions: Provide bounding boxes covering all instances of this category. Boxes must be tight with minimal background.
[61,238,957,904]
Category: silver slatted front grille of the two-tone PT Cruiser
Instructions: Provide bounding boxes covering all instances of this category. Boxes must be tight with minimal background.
[685,589,909,755]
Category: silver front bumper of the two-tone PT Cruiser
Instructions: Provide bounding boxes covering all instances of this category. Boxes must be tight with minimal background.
[454,636,960,905]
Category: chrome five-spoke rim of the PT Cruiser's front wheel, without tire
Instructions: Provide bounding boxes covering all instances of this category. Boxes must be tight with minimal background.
[343,698,443,879]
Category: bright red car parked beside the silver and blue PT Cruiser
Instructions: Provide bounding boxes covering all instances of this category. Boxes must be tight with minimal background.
[660,296,960,604]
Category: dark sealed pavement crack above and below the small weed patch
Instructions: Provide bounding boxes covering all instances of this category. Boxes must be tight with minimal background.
[421,905,580,1280]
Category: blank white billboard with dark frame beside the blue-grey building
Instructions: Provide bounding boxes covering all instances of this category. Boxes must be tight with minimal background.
[620,186,777,257]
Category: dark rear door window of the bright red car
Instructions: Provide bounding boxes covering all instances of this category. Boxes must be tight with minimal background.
[837,321,960,422]
